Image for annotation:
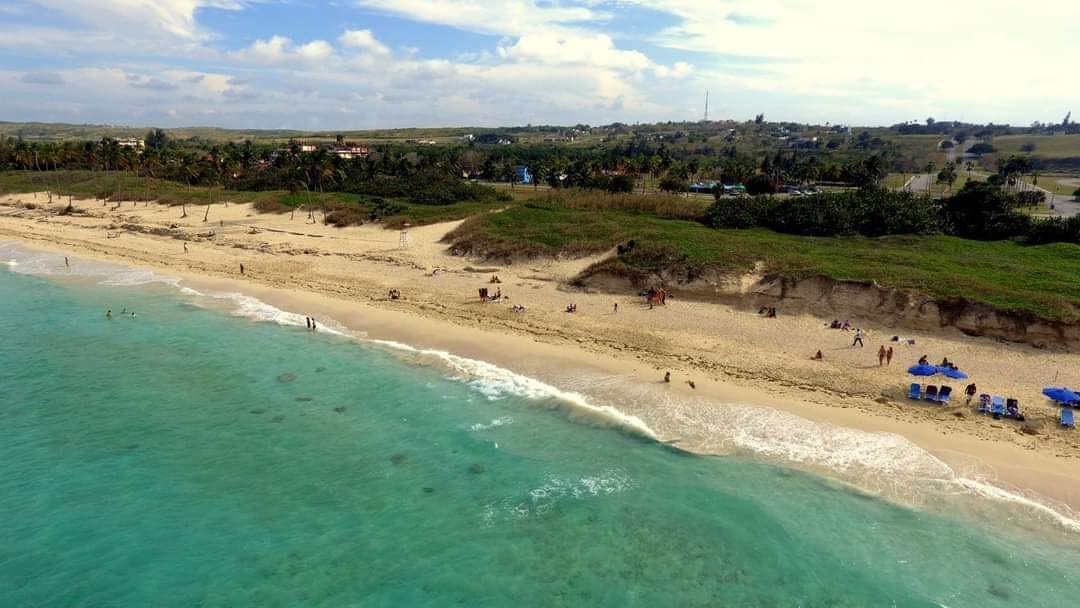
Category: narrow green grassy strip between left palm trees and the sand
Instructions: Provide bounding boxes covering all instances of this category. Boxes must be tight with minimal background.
[0,171,494,228]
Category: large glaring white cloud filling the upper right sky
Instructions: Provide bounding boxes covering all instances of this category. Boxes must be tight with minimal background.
[649,0,1080,120]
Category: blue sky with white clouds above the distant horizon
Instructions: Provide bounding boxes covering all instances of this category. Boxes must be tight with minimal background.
[0,0,1080,130]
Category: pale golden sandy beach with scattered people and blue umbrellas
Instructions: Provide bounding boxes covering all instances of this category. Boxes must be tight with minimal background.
[0,193,1080,510]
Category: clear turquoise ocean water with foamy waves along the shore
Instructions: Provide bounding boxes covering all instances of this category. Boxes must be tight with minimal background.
[0,247,1080,608]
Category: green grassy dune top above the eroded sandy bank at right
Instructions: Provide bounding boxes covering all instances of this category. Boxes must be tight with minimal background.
[453,204,1080,321]
